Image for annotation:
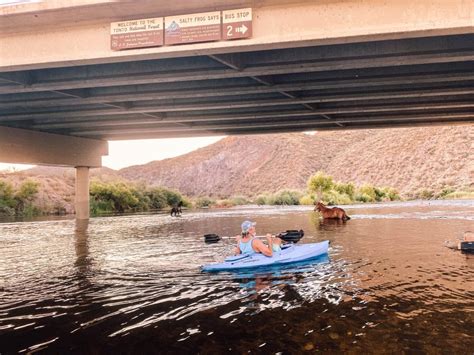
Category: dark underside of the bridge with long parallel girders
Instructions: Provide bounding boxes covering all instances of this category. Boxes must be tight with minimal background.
[0,34,474,140]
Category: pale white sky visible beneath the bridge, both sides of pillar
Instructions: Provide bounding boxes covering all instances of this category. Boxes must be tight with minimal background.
[0,136,224,170]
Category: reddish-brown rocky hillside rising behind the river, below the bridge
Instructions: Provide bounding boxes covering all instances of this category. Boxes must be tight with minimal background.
[119,125,474,197]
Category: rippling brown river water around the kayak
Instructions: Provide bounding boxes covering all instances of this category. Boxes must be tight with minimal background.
[0,201,474,354]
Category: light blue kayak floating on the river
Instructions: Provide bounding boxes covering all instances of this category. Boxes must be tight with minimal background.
[202,240,329,272]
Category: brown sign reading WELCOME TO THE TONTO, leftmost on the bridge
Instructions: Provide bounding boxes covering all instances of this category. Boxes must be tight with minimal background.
[110,17,163,51]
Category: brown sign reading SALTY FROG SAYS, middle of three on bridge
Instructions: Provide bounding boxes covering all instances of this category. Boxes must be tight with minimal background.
[165,11,221,45]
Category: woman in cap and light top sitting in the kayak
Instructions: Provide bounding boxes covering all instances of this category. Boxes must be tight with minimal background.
[235,221,281,256]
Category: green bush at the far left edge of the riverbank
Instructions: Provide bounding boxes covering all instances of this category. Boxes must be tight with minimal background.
[0,179,41,216]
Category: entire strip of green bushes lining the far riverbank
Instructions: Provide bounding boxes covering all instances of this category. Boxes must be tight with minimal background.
[0,172,474,217]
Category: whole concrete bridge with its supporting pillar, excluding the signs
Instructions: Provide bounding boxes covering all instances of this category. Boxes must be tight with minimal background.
[0,0,474,219]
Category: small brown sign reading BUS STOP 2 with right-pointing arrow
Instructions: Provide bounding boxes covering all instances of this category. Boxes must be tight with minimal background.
[222,8,252,40]
